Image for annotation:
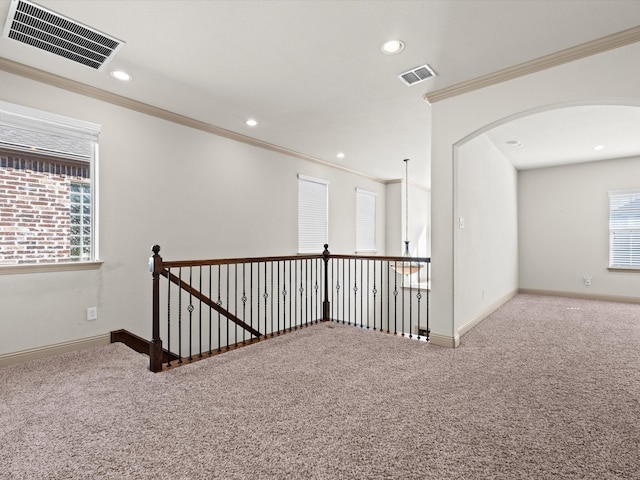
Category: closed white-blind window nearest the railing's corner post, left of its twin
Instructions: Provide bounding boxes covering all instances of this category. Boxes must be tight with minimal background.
[298,175,329,253]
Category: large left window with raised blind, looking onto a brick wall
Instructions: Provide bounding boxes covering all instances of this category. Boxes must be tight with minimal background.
[0,102,100,265]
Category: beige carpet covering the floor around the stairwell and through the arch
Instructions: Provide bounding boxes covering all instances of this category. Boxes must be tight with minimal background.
[0,295,640,480]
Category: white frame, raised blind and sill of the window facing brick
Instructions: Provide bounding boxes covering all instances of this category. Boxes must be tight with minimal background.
[0,101,102,275]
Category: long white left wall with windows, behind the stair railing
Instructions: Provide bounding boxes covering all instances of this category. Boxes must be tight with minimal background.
[0,72,386,355]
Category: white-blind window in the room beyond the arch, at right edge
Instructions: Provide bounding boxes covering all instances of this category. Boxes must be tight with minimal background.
[609,190,640,268]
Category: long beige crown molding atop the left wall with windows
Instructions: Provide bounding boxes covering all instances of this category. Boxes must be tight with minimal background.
[0,57,385,184]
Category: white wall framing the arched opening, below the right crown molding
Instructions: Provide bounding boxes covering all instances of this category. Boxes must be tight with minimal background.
[431,40,640,344]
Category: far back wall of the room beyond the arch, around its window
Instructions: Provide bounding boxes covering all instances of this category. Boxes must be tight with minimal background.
[519,157,640,299]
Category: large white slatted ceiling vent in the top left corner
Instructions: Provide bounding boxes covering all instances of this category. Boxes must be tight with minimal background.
[2,0,124,70]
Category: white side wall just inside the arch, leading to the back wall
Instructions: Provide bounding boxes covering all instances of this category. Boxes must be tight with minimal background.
[454,135,518,331]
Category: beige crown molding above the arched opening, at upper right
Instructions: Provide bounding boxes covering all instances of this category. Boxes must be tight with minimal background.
[422,26,640,103]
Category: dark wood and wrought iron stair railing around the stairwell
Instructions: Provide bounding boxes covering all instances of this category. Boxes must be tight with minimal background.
[149,245,430,372]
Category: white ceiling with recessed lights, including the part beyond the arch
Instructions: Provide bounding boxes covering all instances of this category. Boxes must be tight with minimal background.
[0,0,640,185]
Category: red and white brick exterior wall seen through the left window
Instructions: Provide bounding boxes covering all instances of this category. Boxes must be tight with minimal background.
[0,153,90,265]
